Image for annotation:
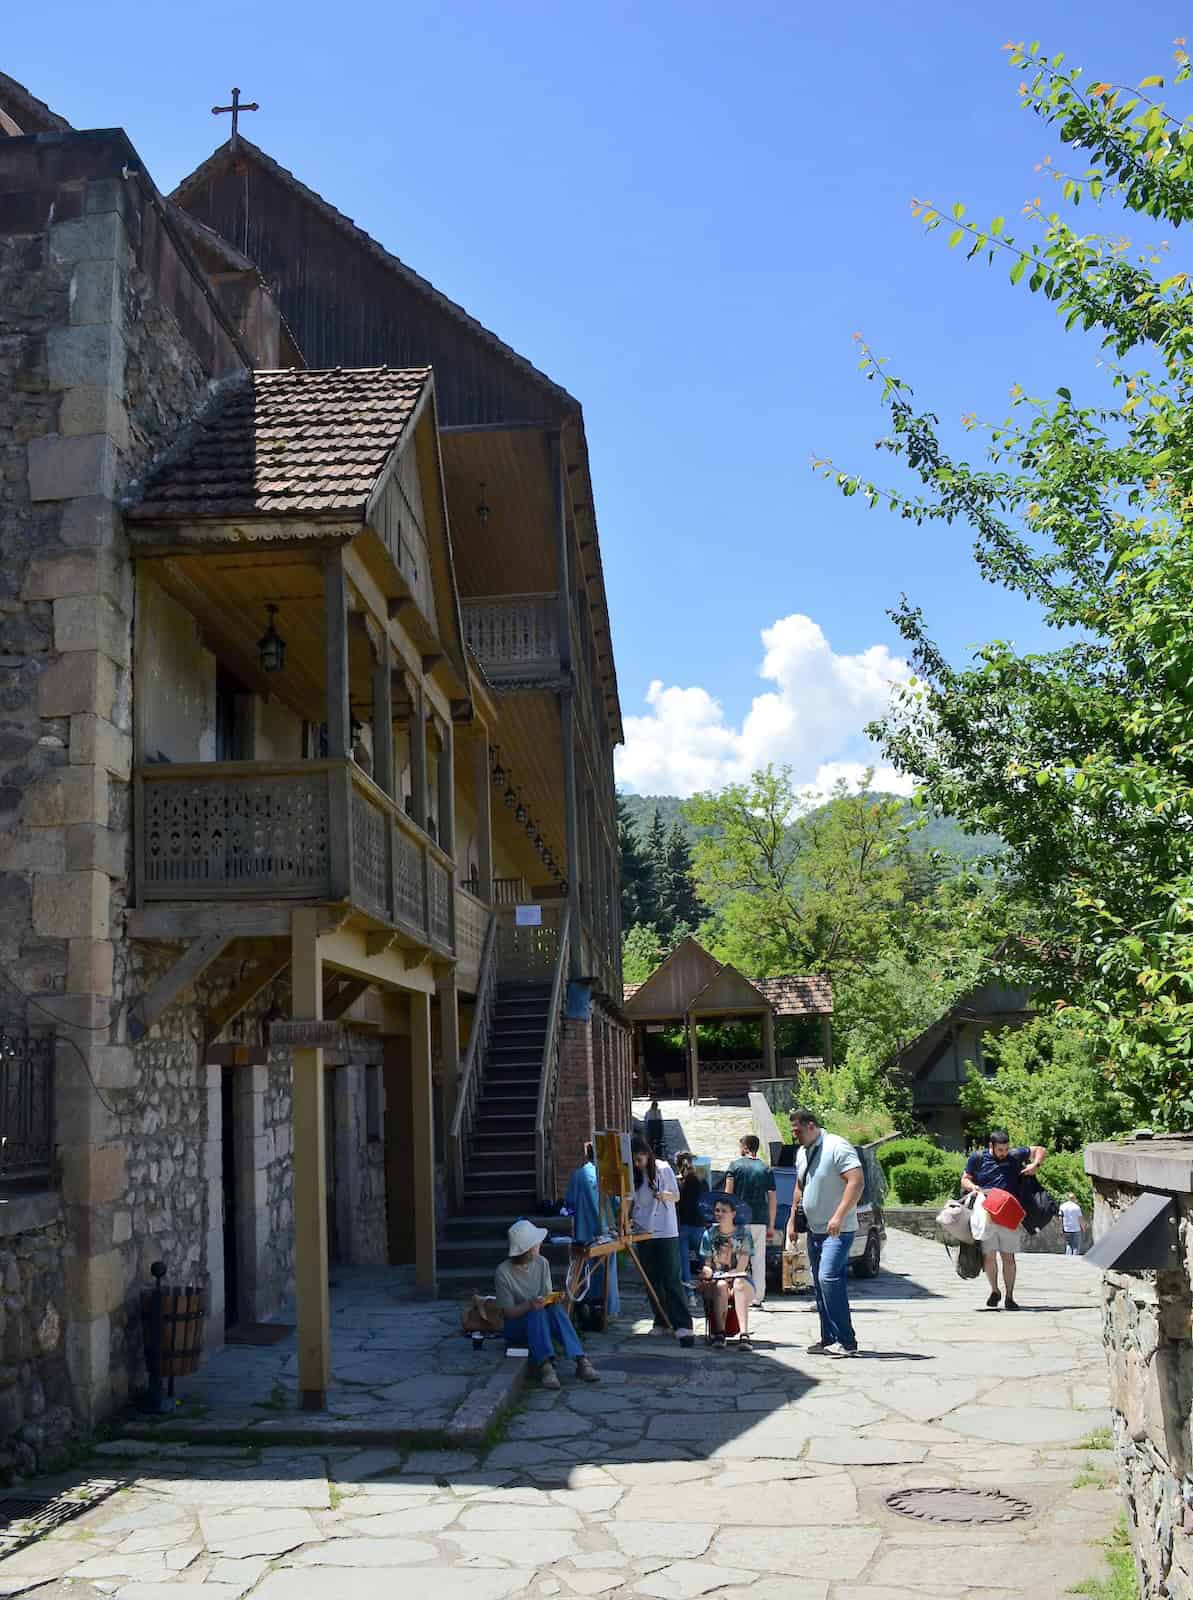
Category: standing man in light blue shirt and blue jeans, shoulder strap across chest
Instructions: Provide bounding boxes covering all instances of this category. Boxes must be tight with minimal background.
[787,1110,865,1360]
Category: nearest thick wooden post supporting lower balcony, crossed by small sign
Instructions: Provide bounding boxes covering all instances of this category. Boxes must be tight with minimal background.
[289,909,331,1411]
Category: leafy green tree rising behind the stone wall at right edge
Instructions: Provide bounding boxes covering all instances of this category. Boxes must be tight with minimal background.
[822,45,1193,1126]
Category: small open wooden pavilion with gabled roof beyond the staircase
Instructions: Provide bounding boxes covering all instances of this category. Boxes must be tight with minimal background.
[625,938,833,1104]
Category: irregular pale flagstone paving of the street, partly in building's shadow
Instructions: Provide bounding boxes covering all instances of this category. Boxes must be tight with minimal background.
[0,1234,1116,1600]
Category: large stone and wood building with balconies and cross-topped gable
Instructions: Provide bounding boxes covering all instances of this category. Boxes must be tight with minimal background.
[0,75,630,1467]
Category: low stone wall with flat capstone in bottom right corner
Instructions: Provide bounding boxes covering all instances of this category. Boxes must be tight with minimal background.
[1086,1139,1193,1600]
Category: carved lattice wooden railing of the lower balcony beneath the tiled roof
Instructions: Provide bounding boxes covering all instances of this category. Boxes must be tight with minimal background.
[134,760,456,955]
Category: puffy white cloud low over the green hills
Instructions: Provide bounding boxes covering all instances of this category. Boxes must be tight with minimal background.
[617,613,912,795]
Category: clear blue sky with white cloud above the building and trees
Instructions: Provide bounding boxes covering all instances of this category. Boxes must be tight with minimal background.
[9,0,1190,789]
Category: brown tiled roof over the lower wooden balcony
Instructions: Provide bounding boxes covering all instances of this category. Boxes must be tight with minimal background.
[125,366,430,522]
